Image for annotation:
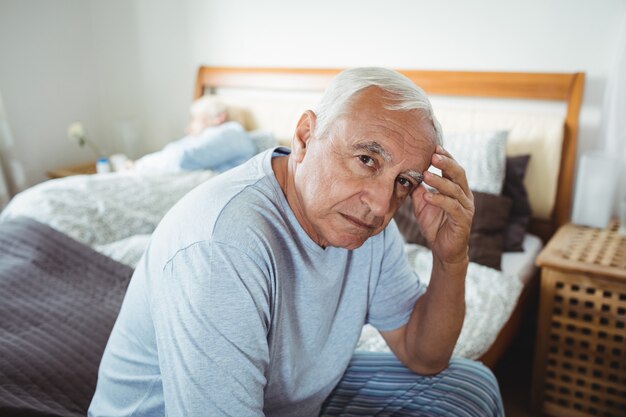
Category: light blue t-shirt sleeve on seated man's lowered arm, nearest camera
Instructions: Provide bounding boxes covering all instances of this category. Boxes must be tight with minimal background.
[151,242,270,416]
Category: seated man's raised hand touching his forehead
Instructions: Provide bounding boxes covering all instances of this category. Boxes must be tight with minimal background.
[411,146,474,264]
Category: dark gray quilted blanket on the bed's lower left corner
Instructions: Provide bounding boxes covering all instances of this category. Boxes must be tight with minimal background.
[0,218,132,416]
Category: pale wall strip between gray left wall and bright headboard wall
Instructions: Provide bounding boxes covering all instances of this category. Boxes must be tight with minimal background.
[90,0,196,157]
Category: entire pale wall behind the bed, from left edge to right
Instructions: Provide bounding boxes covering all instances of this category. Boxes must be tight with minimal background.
[0,0,626,200]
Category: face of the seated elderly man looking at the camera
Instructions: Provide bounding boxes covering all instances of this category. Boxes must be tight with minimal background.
[294,88,436,249]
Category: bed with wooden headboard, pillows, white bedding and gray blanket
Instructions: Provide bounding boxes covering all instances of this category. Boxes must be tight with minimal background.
[0,67,584,415]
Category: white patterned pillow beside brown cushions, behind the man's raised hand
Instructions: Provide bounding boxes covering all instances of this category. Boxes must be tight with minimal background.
[430,131,508,194]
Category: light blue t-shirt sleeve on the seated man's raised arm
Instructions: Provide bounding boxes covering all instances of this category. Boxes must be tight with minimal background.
[367,220,426,331]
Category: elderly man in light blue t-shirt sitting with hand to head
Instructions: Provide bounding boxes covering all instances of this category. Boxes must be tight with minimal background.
[90,68,503,417]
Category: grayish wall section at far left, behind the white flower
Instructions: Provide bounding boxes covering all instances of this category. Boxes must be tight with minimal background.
[0,0,99,191]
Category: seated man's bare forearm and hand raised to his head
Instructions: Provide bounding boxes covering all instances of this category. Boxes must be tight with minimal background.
[381,146,474,374]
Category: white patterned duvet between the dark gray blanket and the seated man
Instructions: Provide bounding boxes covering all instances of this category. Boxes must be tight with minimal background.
[0,171,216,260]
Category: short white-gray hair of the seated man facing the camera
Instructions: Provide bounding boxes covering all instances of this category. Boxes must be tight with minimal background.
[315,67,443,145]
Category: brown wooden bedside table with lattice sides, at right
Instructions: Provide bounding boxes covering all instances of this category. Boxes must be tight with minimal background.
[532,222,626,417]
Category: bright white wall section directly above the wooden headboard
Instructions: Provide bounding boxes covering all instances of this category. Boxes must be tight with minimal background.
[184,0,626,151]
